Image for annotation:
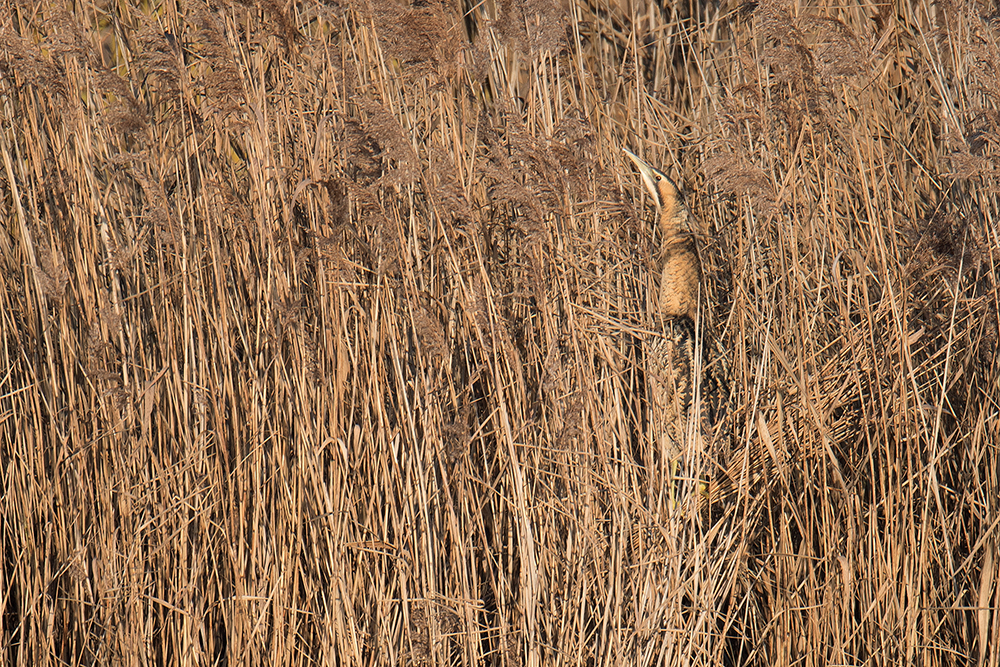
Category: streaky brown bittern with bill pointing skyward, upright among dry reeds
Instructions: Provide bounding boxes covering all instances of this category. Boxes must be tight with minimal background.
[625,149,701,486]
